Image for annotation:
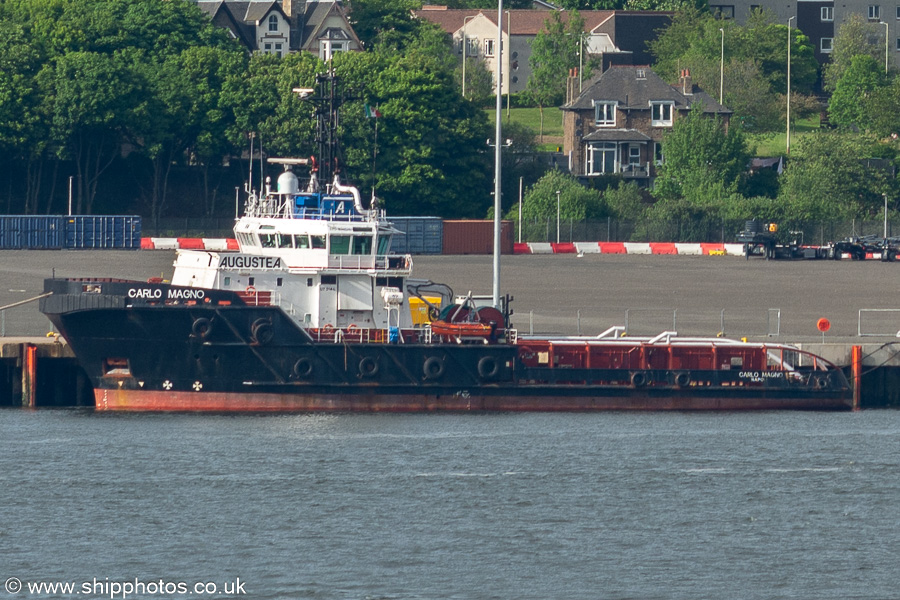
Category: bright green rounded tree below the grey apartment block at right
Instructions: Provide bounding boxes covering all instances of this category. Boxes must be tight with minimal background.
[828,54,886,130]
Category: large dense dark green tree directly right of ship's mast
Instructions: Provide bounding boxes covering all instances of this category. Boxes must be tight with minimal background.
[335,27,491,217]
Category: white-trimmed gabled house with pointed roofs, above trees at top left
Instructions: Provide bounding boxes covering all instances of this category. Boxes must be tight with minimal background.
[197,0,362,60]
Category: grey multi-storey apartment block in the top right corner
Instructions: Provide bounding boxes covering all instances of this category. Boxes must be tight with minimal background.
[724,0,900,67]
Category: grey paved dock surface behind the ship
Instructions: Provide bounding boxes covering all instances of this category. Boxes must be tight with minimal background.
[0,250,900,343]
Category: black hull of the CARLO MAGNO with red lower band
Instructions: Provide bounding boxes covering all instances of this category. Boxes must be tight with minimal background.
[42,281,851,412]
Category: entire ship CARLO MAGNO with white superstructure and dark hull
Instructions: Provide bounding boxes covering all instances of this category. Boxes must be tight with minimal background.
[40,73,851,412]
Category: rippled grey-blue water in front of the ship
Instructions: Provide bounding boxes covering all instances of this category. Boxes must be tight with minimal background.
[0,410,900,600]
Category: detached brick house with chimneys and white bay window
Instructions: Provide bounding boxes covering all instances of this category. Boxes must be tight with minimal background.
[562,66,731,185]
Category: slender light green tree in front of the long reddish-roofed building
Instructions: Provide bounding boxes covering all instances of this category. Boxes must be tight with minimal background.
[527,11,584,138]
